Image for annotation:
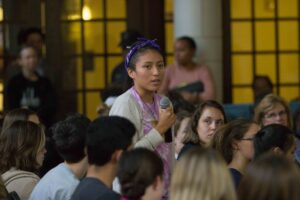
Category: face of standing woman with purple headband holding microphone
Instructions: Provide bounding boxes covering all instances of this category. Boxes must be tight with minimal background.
[128,50,165,92]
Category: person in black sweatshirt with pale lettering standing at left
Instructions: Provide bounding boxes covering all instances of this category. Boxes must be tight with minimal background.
[5,46,56,127]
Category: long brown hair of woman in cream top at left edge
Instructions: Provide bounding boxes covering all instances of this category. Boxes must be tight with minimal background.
[0,121,45,174]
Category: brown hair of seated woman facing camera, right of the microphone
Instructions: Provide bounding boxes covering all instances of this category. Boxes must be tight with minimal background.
[183,100,227,144]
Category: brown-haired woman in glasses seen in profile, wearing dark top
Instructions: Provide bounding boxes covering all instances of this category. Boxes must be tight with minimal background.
[212,119,260,188]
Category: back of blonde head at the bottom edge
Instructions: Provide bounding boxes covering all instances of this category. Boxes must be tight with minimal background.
[170,147,236,200]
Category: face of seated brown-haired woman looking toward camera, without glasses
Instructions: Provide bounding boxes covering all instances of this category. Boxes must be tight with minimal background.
[197,107,224,145]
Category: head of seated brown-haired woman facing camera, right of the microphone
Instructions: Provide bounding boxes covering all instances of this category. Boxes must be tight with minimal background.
[178,100,227,159]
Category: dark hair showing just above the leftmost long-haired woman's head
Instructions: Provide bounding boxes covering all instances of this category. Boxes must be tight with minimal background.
[2,108,37,131]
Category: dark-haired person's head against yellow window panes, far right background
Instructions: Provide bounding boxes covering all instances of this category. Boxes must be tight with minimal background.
[252,76,273,104]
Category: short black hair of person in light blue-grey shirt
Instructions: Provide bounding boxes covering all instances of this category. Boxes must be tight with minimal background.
[52,113,91,163]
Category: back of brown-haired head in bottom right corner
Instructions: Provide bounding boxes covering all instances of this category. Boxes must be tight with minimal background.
[238,153,300,200]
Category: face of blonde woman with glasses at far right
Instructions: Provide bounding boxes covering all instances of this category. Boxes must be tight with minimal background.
[262,103,288,126]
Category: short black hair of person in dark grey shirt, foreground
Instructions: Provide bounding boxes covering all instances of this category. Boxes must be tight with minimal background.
[86,116,135,166]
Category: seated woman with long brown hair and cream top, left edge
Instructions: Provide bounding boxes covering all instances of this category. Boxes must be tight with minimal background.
[0,121,46,200]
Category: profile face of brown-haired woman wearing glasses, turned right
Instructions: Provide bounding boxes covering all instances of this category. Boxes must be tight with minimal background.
[236,123,260,161]
